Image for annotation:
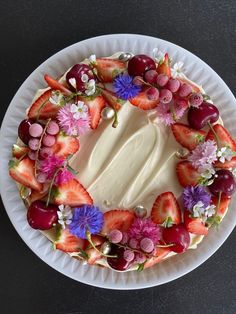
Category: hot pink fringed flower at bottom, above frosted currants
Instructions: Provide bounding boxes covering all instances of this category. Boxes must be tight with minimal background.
[128,218,161,244]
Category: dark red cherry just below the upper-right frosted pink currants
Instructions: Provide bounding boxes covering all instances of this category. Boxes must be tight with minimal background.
[188,102,219,130]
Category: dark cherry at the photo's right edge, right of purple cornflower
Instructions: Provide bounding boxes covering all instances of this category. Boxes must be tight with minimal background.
[209,169,236,197]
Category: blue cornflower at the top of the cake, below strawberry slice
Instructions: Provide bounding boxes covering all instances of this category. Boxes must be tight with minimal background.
[113,74,141,100]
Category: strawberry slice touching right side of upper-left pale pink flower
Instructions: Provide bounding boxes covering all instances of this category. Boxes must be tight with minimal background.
[80,96,106,129]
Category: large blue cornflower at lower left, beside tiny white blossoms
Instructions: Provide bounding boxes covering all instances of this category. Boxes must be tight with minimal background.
[69,205,103,239]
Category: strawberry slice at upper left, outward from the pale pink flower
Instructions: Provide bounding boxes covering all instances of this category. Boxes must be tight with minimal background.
[28,89,61,120]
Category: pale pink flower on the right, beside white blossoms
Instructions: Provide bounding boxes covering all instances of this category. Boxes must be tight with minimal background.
[188,140,217,172]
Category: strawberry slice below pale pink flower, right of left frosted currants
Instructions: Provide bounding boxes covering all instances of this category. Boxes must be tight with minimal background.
[52,133,79,158]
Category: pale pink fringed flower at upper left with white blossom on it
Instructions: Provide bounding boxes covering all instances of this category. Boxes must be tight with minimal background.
[57,104,90,136]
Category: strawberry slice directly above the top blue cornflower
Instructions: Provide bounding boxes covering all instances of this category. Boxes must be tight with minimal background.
[95,58,126,83]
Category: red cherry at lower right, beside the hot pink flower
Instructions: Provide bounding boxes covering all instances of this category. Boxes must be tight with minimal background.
[162,224,190,253]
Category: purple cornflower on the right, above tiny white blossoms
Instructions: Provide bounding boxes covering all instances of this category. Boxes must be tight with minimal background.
[182,185,211,211]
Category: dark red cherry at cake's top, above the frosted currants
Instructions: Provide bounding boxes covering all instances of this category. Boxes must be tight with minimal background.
[128,55,156,76]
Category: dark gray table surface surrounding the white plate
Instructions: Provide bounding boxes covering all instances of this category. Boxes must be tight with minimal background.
[0,0,236,314]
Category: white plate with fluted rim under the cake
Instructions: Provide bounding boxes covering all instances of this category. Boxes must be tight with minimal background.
[0,34,236,290]
